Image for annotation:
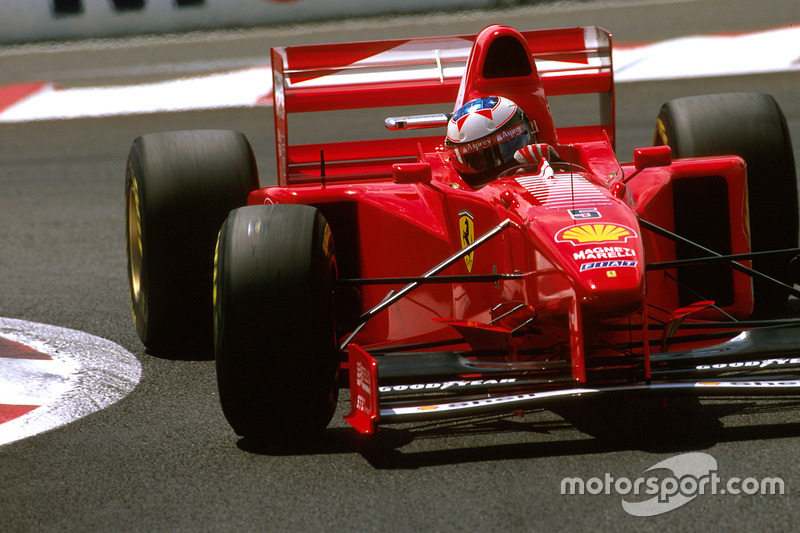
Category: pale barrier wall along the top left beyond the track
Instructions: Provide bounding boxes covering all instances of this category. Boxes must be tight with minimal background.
[0,0,492,43]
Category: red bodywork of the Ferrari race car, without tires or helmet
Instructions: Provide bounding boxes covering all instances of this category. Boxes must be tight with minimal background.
[256,26,764,433]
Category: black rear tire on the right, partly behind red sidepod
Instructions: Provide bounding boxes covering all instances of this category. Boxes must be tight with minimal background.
[655,93,798,316]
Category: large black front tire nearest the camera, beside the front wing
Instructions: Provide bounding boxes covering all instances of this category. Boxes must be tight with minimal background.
[214,205,339,445]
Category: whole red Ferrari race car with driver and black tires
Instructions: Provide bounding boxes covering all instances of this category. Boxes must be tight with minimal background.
[126,25,800,442]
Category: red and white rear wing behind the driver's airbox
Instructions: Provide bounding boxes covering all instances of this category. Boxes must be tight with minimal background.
[271,26,615,186]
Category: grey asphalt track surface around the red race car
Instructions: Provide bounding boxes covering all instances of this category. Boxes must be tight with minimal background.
[0,0,800,531]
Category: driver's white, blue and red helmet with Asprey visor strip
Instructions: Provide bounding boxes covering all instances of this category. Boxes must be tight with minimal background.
[445,96,536,185]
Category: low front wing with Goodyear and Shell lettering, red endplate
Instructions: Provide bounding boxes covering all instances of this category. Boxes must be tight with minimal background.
[345,321,800,435]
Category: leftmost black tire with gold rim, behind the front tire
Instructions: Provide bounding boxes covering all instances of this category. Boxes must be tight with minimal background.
[125,130,259,356]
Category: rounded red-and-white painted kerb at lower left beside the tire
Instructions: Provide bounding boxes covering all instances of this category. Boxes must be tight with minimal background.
[0,318,142,445]
